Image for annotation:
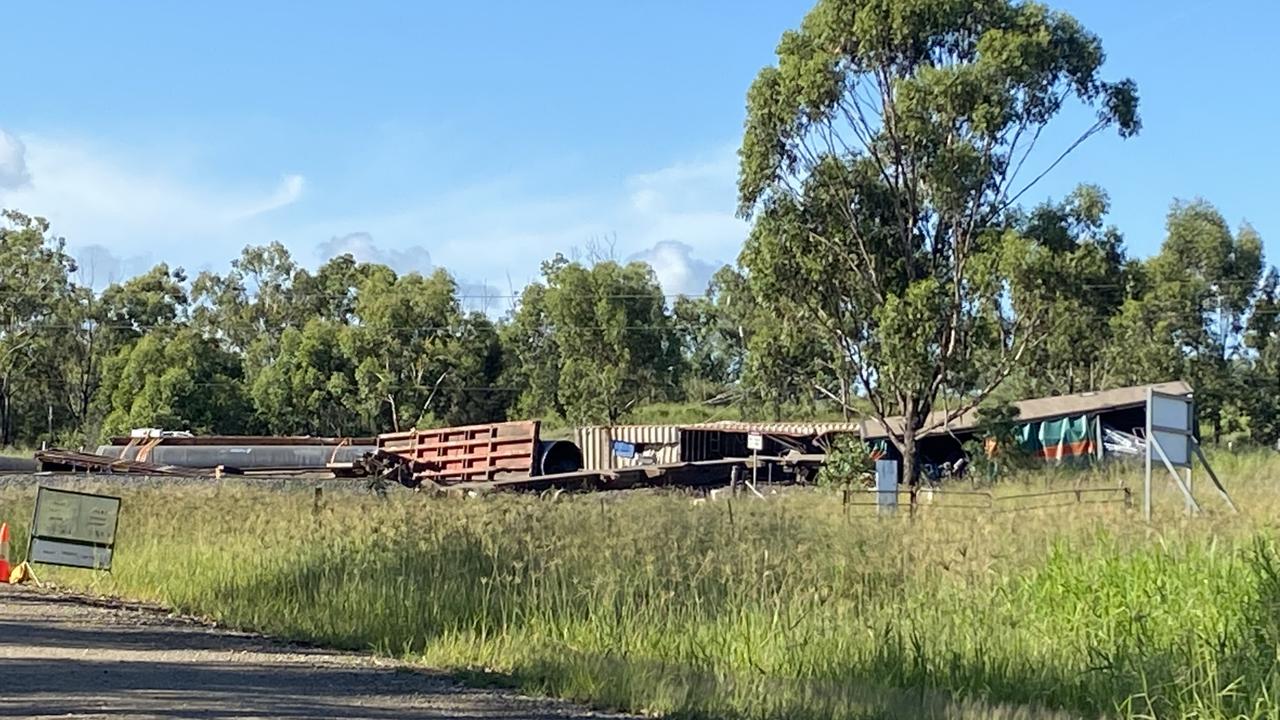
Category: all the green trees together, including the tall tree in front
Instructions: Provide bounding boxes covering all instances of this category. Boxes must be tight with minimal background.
[0,0,1280,478]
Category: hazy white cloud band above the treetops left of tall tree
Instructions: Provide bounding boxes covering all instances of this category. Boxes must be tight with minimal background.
[0,126,746,302]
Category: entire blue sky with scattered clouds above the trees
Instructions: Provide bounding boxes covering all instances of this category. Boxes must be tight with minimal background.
[0,0,1280,302]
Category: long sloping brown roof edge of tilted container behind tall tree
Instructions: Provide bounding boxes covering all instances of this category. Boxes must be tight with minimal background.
[863,380,1192,439]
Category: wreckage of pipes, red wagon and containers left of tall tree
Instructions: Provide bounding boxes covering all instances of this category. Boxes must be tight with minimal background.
[36,420,820,492]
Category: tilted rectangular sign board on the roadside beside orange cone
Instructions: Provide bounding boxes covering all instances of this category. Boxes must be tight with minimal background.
[27,486,120,570]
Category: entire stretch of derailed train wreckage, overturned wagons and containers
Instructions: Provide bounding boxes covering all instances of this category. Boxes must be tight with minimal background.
[15,382,1190,492]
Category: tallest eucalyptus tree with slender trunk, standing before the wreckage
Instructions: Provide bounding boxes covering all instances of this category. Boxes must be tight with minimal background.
[739,0,1139,478]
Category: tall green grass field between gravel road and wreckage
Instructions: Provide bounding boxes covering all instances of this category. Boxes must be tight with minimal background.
[0,455,1280,719]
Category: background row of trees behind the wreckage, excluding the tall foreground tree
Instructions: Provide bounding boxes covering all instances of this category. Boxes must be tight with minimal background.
[0,187,1280,446]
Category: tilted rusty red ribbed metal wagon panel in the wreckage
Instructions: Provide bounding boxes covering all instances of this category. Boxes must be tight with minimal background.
[378,420,539,484]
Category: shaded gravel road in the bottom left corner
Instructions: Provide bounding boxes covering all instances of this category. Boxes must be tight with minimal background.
[0,585,634,720]
